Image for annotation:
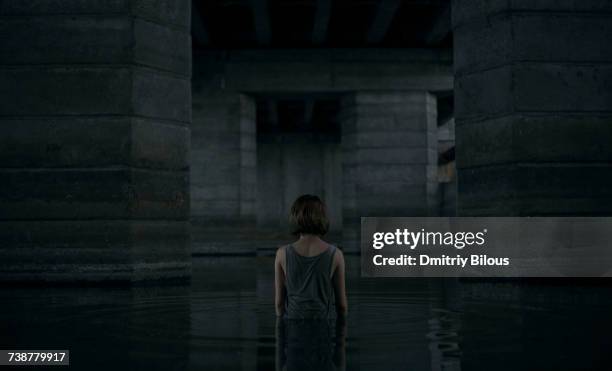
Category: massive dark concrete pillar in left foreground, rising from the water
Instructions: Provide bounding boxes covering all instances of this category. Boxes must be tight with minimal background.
[0,0,191,282]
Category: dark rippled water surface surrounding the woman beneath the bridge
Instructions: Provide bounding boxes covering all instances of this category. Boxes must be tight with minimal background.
[0,257,612,371]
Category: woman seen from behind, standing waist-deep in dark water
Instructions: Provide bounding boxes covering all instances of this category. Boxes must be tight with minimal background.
[274,195,348,319]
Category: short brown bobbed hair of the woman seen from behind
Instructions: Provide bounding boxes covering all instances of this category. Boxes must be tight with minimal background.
[289,195,329,236]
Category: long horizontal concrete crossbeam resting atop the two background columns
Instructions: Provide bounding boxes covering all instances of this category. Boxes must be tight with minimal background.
[195,49,453,93]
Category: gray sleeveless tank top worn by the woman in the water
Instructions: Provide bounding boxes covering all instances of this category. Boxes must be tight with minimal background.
[285,245,336,319]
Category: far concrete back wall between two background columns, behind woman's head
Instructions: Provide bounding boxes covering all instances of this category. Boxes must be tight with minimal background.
[257,133,342,231]
